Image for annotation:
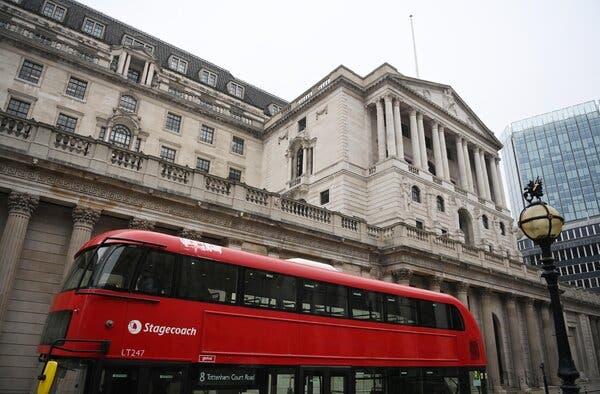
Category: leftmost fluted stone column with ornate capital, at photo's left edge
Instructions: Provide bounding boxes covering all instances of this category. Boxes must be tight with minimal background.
[0,191,39,327]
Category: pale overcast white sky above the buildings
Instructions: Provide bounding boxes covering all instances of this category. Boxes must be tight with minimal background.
[82,0,600,135]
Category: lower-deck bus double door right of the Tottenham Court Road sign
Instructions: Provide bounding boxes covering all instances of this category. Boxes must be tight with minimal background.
[299,367,351,394]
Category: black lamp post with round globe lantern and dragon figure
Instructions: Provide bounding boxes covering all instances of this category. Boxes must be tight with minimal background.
[519,178,579,393]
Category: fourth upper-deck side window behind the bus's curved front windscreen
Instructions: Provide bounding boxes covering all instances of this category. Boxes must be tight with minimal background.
[301,279,348,317]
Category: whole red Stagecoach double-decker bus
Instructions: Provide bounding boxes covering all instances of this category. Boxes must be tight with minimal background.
[38,230,486,394]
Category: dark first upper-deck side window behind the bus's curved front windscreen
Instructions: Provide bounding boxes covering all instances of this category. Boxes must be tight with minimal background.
[133,250,176,297]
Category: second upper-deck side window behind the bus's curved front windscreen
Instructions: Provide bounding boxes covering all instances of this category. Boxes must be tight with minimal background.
[177,256,238,304]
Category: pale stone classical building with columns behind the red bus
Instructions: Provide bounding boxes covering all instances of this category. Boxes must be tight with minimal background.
[0,0,600,393]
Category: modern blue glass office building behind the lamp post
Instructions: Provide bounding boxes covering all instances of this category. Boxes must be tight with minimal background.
[500,101,600,292]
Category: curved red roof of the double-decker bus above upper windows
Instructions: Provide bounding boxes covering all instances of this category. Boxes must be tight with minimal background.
[83,229,464,309]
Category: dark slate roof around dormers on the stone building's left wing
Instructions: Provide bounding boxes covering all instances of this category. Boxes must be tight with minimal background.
[16,0,287,111]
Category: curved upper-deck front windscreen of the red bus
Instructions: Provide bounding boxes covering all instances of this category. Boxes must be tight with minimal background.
[62,244,145,291]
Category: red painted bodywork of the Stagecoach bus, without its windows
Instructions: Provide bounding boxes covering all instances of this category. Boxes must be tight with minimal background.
[39,230,486,367]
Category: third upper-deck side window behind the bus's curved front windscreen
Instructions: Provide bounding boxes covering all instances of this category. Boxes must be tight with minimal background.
[243,268,296,311]
